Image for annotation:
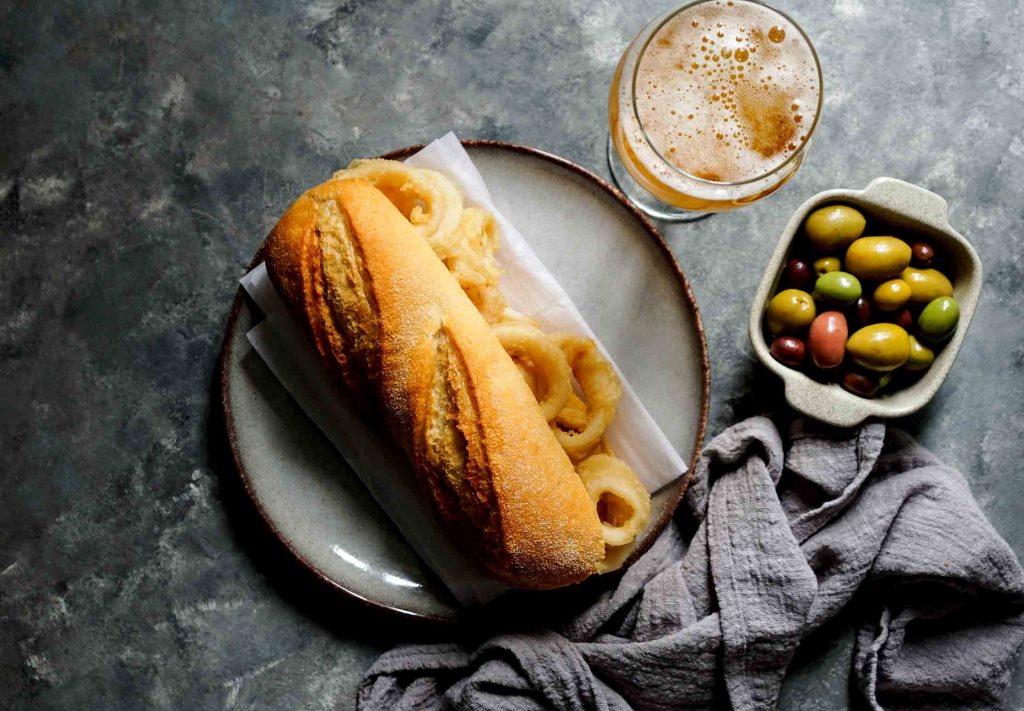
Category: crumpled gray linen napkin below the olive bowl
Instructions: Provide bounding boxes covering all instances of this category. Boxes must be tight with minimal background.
[358,417,1024,710]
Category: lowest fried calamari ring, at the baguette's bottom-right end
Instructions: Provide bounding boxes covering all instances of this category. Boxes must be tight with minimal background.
[578,454,650,547]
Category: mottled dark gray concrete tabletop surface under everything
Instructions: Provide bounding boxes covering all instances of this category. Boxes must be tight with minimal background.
[0,0,1024,709]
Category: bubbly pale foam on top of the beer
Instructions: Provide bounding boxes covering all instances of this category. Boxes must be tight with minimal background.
[633,0,821,182]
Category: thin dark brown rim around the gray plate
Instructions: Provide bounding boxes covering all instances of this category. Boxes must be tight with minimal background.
[217,138,711,624]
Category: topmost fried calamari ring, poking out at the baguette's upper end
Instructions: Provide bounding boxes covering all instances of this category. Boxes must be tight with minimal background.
[334,158,462,259]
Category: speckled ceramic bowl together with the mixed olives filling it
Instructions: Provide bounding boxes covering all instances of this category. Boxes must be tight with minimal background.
[750,177,982,426]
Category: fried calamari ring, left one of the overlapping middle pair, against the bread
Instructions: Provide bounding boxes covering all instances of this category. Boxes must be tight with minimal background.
[494,324,572,422]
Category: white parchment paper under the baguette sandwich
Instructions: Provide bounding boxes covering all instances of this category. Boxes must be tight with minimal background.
[242,133,686,604]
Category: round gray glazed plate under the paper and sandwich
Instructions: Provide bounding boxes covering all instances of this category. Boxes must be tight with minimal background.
[220,141,711,622]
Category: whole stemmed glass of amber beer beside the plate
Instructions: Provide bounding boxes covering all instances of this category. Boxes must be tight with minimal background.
[608,0,822,221]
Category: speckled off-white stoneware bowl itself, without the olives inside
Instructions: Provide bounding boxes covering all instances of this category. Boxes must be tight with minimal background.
[750,177,981,427]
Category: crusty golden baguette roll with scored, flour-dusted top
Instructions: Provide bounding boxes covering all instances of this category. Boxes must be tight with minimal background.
[265,179,604,589]
